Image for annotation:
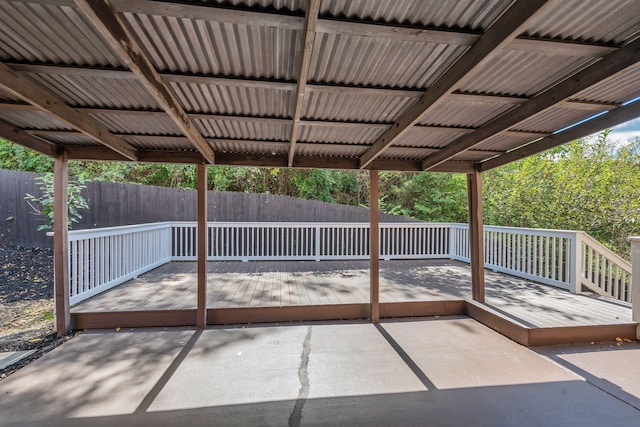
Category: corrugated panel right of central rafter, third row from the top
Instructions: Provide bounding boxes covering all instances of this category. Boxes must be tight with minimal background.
[302,91,417,122]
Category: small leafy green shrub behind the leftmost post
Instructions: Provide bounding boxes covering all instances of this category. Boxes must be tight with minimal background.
[24,173,89,230]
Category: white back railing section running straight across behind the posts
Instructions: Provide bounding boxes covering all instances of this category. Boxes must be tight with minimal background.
[171,222,451,261]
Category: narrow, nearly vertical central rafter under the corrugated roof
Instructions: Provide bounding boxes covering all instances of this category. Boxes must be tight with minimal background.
[288,0,320,167]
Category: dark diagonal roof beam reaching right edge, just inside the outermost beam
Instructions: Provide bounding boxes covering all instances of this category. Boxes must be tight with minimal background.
[422,39,640,170]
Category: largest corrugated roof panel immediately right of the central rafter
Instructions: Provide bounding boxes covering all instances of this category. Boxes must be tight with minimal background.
[309,33,467,88]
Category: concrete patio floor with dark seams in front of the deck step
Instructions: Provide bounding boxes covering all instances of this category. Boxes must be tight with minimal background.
[0,316,640,427]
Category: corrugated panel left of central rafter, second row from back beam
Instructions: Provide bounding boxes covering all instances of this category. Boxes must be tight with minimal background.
[193,118,291,141]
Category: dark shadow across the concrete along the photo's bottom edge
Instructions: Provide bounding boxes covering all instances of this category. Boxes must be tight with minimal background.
[6,381,640,427]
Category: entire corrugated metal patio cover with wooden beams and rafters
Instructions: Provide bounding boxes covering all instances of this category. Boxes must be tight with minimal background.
[0,0,640,173]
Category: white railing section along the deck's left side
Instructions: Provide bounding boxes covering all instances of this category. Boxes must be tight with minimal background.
[69,223,171,304]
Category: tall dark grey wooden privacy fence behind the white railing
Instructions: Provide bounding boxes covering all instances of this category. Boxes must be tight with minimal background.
[0,169,415,247]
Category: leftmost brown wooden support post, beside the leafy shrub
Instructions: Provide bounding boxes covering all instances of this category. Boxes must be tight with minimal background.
[53,151,71,337]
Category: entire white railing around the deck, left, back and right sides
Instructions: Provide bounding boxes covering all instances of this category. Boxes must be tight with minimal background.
[69,222,631,304]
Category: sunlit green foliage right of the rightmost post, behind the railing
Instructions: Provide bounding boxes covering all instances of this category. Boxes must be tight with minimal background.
[484,132,640,257]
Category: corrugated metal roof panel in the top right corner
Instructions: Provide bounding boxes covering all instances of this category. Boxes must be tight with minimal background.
[525,0,640,44]
